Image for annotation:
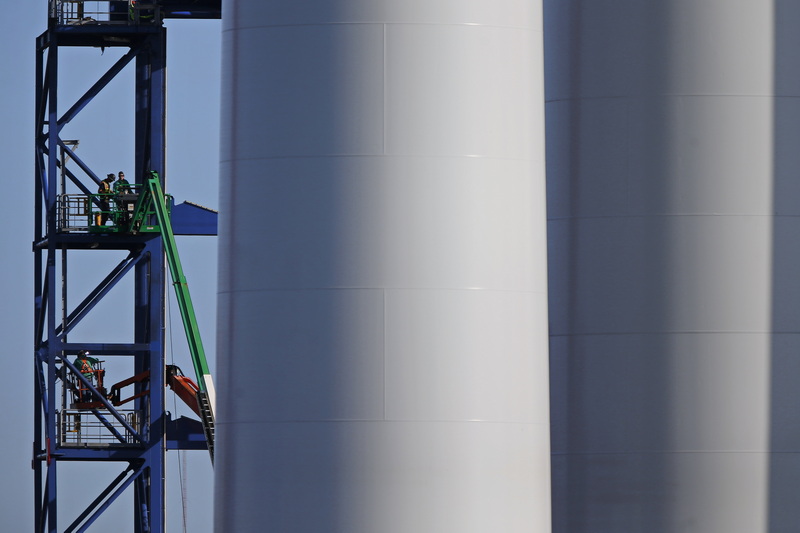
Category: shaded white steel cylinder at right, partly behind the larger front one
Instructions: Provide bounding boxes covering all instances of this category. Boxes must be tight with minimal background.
[545,0,800,533]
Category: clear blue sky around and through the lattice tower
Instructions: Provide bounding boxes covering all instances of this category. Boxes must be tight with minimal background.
[0,4,221,533]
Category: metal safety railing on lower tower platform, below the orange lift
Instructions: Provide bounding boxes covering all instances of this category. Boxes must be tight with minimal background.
[58,409,142,448]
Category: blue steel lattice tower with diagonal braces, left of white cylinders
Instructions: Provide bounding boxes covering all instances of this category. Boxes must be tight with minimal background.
[32,0,220,533]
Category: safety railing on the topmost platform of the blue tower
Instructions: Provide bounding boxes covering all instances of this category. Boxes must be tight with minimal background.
[50,0,161,26]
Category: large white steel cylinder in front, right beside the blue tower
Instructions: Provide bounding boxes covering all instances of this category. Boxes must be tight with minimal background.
[215,0,550,533]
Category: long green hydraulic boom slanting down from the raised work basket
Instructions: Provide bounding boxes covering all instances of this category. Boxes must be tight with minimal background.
[139,171,215,463]
